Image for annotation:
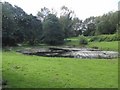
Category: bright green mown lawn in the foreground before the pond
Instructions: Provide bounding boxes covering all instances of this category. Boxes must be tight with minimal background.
[2,52,118,88]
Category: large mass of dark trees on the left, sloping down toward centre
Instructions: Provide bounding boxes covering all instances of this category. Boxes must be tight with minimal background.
[2,2,42,46]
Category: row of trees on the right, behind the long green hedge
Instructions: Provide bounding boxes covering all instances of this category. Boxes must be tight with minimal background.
[82,11,118,36]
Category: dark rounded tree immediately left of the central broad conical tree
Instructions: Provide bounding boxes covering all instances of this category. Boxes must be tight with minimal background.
[21,14,42,45]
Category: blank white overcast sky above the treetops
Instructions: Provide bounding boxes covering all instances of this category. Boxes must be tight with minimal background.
[2,0,120,19]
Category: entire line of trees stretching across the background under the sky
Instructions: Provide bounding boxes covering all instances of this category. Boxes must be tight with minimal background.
[2,2,118,46]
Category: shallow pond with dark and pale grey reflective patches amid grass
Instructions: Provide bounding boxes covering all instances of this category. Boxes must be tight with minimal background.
[17,47,118,59]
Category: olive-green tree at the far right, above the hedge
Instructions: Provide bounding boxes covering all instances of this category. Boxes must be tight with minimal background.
[96,12,118,34]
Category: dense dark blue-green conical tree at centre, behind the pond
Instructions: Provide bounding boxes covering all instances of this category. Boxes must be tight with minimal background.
[43,14,64,45]
